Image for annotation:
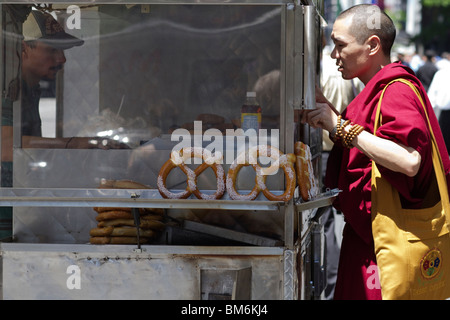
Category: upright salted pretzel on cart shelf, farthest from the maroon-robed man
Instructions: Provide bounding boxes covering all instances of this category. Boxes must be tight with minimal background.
[157,147,225,200]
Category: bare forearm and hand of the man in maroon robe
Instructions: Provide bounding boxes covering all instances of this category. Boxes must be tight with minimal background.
[302,102,421,177]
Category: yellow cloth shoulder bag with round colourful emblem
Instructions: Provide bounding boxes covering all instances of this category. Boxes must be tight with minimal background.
[371,79,450,300]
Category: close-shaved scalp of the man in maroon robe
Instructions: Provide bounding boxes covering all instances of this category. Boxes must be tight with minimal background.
[337,4,396,56]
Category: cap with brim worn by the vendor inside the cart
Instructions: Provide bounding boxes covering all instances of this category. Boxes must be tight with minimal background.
[22,10,84,49]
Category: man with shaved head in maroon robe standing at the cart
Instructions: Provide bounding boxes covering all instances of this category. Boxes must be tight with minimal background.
[302,4,450,300]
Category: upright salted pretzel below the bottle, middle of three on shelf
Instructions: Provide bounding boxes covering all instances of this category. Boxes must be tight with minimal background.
[226,145,296,202]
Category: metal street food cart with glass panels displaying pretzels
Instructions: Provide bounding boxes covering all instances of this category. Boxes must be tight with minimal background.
[0,0,336,300]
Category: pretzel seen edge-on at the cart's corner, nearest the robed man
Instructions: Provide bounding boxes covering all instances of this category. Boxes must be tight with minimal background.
[294,141,319,201]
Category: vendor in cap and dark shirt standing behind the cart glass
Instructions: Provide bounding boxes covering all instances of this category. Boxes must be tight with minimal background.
[0,10,128,239]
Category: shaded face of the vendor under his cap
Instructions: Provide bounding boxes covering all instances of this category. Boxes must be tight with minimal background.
[22,41,66,80]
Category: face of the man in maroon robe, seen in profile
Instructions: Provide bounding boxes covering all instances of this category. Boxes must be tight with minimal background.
[331,17,370,79]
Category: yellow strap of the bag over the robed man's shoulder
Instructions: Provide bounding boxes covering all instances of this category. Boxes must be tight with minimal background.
[372,78,450,206]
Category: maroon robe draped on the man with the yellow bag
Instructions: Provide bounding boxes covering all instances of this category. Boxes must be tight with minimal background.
[325,63,450,299]
